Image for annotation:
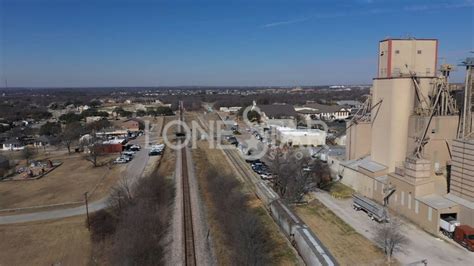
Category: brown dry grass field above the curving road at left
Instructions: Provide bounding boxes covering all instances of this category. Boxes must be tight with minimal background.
[0,154,125,209]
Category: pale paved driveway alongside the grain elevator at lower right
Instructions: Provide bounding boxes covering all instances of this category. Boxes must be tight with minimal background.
[313,192,474,265]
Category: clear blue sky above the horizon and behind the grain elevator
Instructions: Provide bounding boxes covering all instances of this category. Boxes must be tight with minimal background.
[0,0,474,87]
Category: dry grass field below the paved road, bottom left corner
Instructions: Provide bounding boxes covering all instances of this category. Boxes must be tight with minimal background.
[0,216,91,265]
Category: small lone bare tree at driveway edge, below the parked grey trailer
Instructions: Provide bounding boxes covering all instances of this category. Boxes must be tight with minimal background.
[375,217,409,263]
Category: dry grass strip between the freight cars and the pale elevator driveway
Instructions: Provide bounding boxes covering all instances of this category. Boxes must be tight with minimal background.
[295,200,385,265]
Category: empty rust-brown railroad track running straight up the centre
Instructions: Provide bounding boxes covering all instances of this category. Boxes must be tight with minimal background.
[180,102,196,266]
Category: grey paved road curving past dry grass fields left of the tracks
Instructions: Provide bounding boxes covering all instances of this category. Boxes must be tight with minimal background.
[0,120,163,224]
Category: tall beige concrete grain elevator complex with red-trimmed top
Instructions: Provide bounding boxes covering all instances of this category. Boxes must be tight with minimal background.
[338,38,474,234]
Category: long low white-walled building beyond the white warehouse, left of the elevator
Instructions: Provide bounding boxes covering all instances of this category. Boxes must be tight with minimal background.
[295,103,351,120]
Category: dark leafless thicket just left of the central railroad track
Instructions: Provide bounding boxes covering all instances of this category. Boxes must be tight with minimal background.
[90,171,175,265]
